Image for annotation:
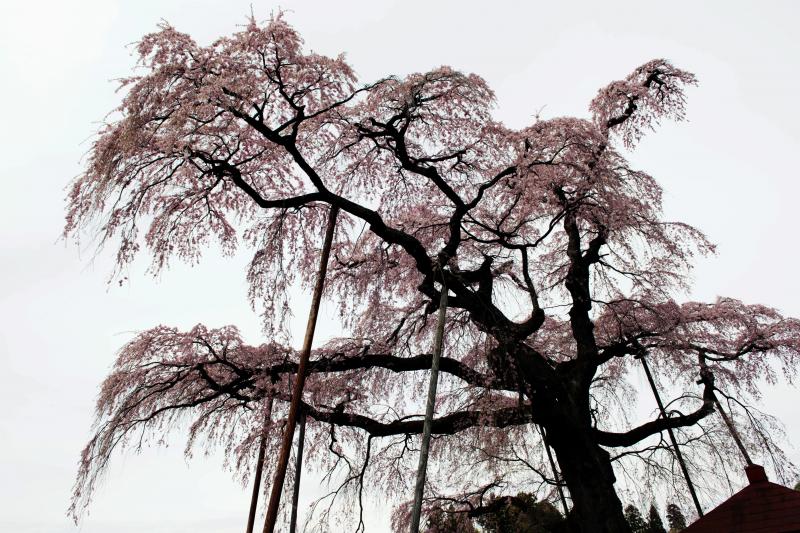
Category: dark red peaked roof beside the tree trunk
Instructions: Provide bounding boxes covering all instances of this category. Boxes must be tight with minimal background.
[683,465,800,533]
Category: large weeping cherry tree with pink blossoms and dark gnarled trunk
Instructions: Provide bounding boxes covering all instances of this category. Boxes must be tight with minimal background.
[65,12,800,532]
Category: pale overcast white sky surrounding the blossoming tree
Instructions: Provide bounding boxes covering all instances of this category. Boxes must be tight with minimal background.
[0,0,800,533]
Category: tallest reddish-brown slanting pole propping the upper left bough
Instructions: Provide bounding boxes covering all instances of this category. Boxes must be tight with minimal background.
[263,206,339,533]
